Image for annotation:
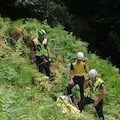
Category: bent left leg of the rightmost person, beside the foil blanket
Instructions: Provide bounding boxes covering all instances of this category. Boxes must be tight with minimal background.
[78,97,94,112]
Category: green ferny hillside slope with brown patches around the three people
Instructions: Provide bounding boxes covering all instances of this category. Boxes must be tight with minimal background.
[0,18,120,120]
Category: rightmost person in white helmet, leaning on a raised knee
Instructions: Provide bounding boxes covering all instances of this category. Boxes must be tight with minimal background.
[78,69,105,120]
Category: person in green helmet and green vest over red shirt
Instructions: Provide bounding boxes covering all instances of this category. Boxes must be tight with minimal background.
[30,29,51,77]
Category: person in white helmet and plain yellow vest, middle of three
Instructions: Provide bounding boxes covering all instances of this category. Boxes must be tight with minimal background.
[67,52,89,102]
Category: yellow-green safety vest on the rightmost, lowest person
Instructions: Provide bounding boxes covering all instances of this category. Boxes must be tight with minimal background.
[88,78,104,100]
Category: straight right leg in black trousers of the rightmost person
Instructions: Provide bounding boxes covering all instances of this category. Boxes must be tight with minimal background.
[95,100,104,120]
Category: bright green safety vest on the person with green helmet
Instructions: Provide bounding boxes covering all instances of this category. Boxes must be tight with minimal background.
[33,38,47,56]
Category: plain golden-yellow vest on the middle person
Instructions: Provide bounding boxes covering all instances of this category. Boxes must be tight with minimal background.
[72,60,85,76]
